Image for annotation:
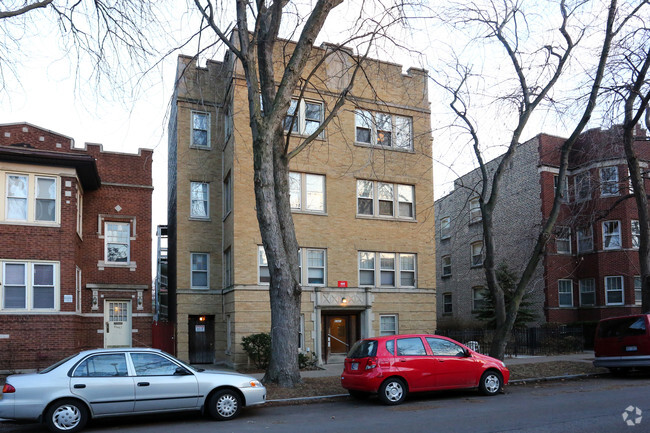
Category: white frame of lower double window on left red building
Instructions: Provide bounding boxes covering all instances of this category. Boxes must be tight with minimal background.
[0,260,61,312]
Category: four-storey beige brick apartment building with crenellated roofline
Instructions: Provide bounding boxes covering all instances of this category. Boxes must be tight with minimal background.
[169,38,436,366]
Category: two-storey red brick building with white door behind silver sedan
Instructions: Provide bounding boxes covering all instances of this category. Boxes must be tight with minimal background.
[0,123,153,371]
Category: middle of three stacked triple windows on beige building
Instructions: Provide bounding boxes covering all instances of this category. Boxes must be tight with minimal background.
[357,180,415,219]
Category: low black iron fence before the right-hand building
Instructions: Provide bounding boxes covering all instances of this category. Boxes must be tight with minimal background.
[436,326,585,356]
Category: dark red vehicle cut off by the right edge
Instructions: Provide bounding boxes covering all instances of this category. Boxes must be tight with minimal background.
[594,314,650,373]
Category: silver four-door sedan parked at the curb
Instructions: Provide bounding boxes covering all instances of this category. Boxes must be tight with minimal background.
[0,348,266,433]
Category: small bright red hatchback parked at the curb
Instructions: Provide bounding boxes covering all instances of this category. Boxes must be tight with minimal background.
[341,335,510,405]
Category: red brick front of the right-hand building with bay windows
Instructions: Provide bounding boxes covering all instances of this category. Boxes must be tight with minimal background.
[539,123,650,323]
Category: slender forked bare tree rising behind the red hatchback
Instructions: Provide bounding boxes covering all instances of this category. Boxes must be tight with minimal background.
[436,0,625,359]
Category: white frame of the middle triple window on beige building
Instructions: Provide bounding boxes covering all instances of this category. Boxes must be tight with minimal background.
[356,179,416,221]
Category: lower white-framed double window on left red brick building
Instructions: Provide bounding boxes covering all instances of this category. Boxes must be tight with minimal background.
[0,261,60,311]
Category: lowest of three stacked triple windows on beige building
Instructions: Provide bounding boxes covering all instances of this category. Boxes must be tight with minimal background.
[359,251,417,287]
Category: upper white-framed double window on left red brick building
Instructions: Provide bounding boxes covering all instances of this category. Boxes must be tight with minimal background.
[3,173,60,224]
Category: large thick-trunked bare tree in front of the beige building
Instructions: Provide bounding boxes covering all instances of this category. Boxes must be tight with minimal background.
[194,0,410,387]
